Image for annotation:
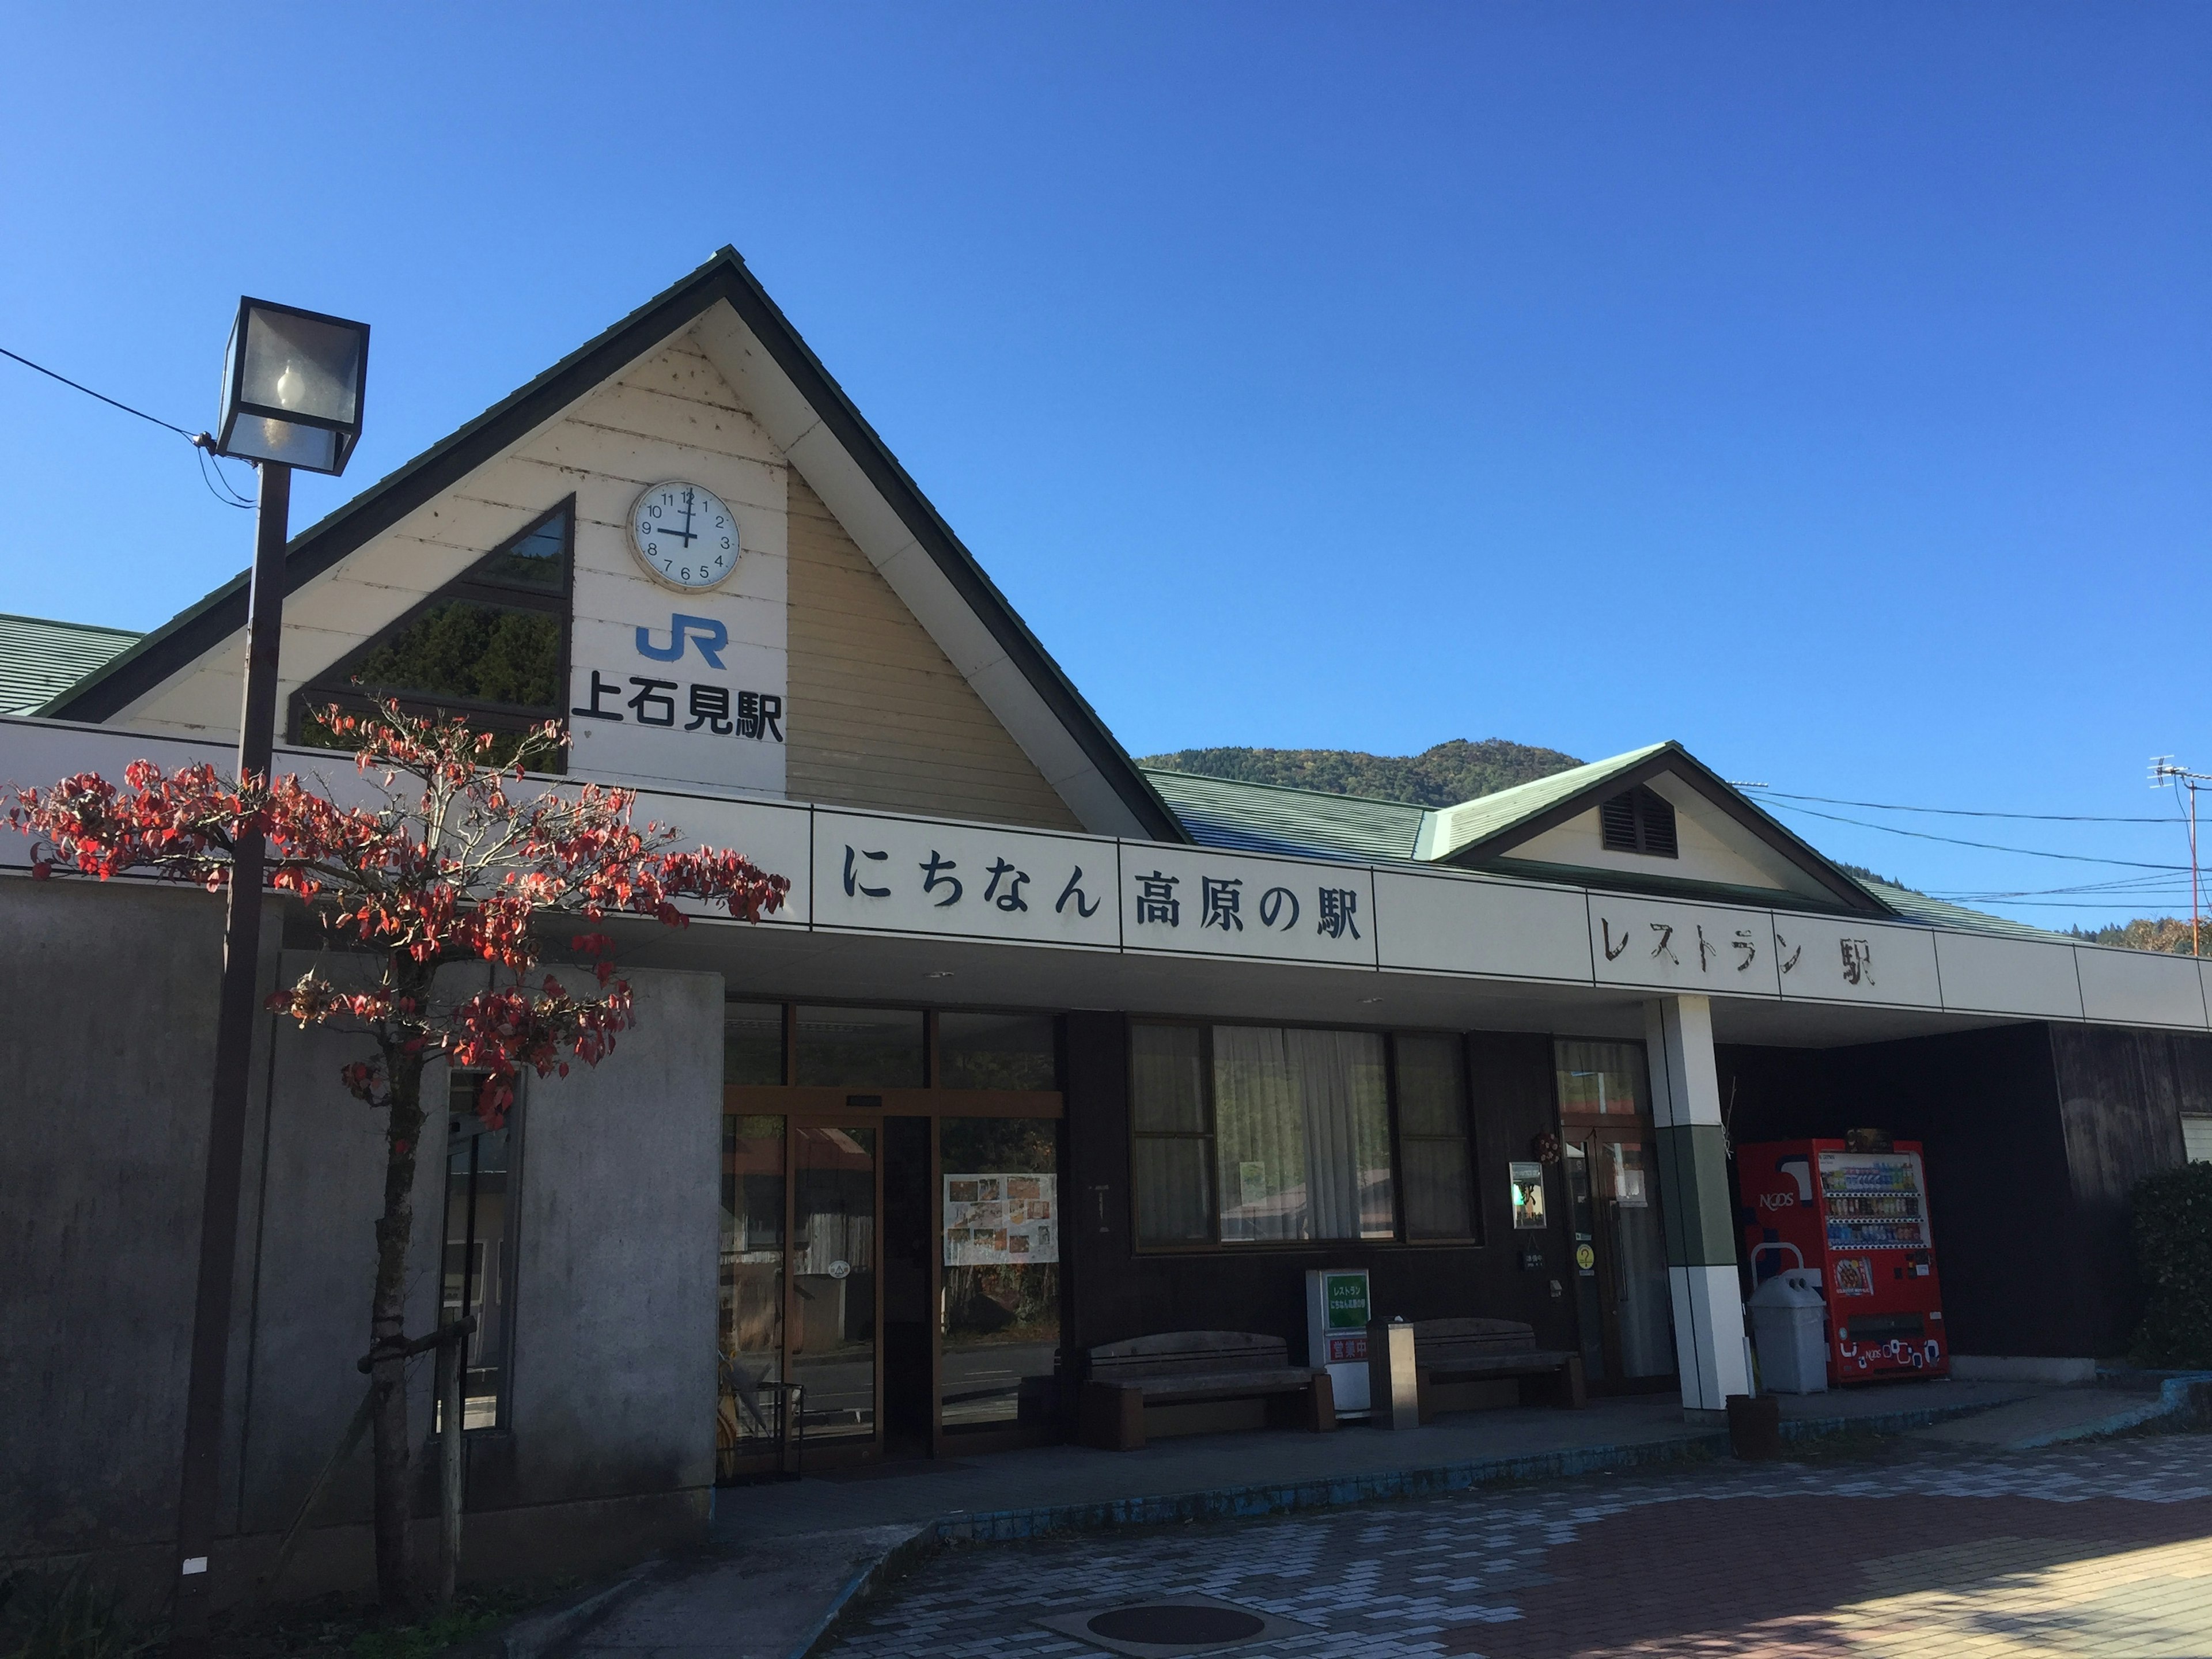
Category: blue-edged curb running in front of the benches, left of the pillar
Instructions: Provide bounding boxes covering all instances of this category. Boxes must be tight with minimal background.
[925,1433,1728,1544]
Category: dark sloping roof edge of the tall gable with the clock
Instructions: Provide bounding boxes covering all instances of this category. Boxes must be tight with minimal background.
[37,248,1185,840]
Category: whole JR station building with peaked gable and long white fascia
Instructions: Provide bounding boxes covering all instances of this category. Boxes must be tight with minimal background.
[0,250,2212,1590]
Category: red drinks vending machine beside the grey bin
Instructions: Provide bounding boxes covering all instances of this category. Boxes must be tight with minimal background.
[1736,1141,1951,1382]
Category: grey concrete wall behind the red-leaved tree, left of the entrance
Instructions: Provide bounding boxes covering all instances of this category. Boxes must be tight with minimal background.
[0,880,721,1601]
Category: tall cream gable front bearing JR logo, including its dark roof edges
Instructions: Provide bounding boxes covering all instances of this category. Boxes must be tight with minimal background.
[47,252,1179,838]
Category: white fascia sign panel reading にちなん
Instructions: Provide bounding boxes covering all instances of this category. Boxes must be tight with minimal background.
[814,812,1122,949]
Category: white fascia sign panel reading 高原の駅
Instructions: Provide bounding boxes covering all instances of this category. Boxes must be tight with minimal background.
[1122,845,1376,967]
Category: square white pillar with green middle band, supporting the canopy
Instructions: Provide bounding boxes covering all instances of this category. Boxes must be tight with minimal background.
[1643,995,1752,1422]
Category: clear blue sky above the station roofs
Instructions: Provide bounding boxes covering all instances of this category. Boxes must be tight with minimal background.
[0,5,2212,925]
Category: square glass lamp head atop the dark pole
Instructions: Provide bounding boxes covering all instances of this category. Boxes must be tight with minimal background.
[214,298,369,474]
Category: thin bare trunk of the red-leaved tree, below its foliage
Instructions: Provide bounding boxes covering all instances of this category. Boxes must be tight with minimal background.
[369,1048,422,1611]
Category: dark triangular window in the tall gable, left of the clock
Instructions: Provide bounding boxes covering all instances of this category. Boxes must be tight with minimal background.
[292,495,575,770]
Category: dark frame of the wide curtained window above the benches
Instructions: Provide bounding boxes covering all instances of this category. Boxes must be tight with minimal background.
[1122,1013,1488,1256]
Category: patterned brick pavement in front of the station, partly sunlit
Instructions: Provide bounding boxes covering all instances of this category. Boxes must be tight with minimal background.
[830,1435,2212,1659]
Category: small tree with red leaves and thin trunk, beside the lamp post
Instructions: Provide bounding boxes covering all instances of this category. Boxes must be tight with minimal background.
[9,703,790,1608]
